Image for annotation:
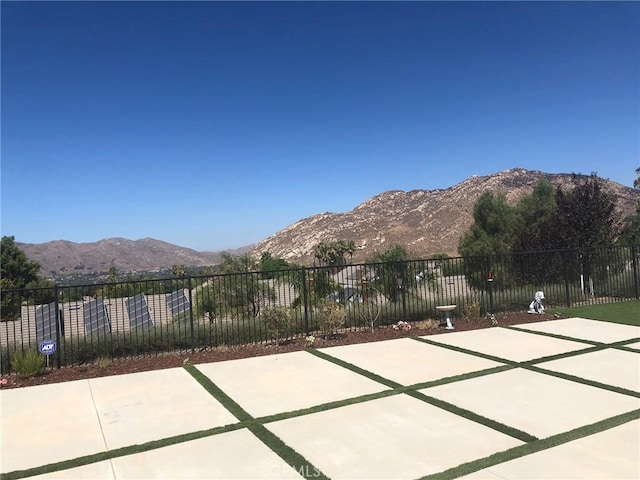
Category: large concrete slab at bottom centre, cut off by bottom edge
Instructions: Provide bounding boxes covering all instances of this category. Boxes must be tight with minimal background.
[266,394,522,480]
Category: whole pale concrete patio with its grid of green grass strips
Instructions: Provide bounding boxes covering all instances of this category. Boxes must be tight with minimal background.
[0,318,640,479]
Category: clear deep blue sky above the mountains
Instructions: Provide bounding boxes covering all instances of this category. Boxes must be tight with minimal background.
[1,1,640,250]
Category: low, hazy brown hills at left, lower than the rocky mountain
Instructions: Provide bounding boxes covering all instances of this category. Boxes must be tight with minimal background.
[16,238,240,275]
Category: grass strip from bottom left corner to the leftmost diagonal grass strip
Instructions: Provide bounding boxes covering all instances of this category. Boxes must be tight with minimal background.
[0,423,244,480]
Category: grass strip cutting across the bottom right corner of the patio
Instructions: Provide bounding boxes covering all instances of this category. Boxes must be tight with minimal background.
[419,409,640,480]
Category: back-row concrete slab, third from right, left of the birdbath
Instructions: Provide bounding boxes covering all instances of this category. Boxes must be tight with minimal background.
[321,338,503,385]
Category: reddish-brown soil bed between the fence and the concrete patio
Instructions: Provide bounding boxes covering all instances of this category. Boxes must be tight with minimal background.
[2,313,554,388]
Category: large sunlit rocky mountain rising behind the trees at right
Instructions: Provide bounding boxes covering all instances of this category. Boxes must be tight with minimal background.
[252,168,640,264]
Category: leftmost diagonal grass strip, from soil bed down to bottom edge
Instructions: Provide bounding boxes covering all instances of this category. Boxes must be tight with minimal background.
[184,365,328,480]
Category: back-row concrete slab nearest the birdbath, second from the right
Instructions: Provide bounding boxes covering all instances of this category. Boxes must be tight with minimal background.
[424,328,588,362]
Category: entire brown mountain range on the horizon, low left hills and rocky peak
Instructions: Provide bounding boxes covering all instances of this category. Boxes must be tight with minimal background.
[16,168,640,276]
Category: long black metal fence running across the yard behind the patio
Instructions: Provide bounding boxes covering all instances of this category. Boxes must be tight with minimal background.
[0,246,640,373]
